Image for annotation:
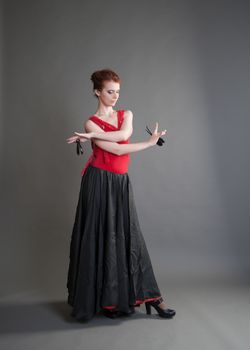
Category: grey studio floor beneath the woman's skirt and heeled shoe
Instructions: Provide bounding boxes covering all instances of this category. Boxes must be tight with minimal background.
[0,282,250,350]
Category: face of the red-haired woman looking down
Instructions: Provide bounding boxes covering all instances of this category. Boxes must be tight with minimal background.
[95,81,120,106]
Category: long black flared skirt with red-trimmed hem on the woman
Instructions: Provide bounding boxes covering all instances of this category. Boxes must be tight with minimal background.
[67,165,161,320]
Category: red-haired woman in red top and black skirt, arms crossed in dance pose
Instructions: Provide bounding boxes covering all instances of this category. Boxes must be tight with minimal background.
[67,69,175,320]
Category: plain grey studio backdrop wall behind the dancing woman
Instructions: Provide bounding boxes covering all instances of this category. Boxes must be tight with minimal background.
[0,0,250,295]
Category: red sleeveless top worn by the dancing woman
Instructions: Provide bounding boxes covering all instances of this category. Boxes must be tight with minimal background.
[81,110,130,175]
